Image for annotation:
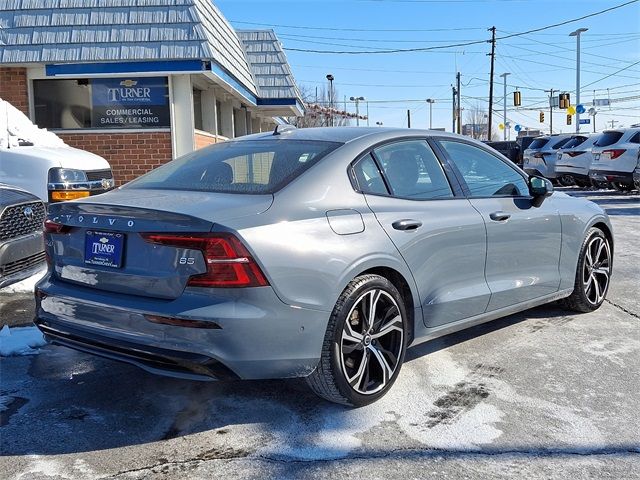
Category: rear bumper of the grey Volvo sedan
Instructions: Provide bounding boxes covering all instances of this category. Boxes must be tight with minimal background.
[35,274,329,380]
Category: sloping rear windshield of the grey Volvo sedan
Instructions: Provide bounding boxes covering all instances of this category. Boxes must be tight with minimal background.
[124,139,342,194]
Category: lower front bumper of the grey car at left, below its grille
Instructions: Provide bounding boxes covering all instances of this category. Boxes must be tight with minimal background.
[0,232,45,288]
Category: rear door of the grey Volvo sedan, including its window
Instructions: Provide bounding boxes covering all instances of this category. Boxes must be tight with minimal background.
[353,139,490,327]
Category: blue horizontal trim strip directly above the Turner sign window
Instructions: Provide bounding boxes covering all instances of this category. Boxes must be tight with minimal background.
[45,60,206,77]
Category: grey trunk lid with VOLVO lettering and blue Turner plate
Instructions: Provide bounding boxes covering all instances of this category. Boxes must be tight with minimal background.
[46,190,273,299]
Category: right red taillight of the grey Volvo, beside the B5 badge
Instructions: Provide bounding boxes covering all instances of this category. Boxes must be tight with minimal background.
[140,233,269,288]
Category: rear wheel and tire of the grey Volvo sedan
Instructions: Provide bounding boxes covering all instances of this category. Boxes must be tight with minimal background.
[307,275,409,407]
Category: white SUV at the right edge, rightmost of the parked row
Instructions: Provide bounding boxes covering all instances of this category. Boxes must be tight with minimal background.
[589,128,640,191]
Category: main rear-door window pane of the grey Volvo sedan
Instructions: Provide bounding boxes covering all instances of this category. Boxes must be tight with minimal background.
[374,140,453,200]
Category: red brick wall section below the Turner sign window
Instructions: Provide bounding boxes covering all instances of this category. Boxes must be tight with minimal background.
[58,132,172,185]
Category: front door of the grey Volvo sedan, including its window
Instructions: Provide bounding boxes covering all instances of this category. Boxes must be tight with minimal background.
[437,138,562,311]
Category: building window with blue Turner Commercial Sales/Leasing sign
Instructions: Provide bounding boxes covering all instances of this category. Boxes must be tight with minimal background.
[33,77,170,129]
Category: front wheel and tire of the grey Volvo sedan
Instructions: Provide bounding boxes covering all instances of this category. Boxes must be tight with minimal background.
[562,227,613,313]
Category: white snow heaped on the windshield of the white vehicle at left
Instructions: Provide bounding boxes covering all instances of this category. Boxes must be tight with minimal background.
[0,98,65,148]
